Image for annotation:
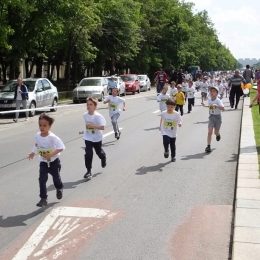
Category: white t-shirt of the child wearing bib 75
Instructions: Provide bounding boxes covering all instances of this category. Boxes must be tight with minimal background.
[161,111,182,138]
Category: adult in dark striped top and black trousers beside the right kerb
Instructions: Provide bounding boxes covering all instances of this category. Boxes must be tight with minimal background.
[229,70,246,109]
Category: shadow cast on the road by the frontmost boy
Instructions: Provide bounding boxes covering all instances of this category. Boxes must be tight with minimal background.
[0,202,58,228]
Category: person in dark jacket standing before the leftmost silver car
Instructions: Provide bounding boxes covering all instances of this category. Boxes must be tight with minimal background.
[13,78,29,123]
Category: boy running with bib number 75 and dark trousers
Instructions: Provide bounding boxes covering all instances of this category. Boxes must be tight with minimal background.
[159,99,182,162]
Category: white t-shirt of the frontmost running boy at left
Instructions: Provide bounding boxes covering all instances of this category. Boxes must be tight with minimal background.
[32,132,65,162]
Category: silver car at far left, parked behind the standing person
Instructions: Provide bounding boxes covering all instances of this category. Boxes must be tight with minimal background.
[0,78,59,116]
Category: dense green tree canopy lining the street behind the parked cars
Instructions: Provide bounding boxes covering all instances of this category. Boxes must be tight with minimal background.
[0,0,237,83]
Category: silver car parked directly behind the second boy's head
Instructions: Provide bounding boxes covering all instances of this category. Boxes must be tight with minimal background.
[73,77,108,103]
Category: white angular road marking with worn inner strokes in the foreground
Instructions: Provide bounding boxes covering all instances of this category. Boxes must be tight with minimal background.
[13,207,110,260]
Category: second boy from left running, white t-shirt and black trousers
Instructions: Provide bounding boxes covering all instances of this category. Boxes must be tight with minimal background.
[79,97,107,180]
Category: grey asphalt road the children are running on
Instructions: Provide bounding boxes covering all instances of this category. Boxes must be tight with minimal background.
[0,90,244,260]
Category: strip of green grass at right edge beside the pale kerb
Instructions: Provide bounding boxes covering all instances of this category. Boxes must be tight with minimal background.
[250,89,260,166]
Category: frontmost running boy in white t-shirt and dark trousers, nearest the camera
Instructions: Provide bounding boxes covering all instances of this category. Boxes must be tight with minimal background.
[28,113,65,207]
